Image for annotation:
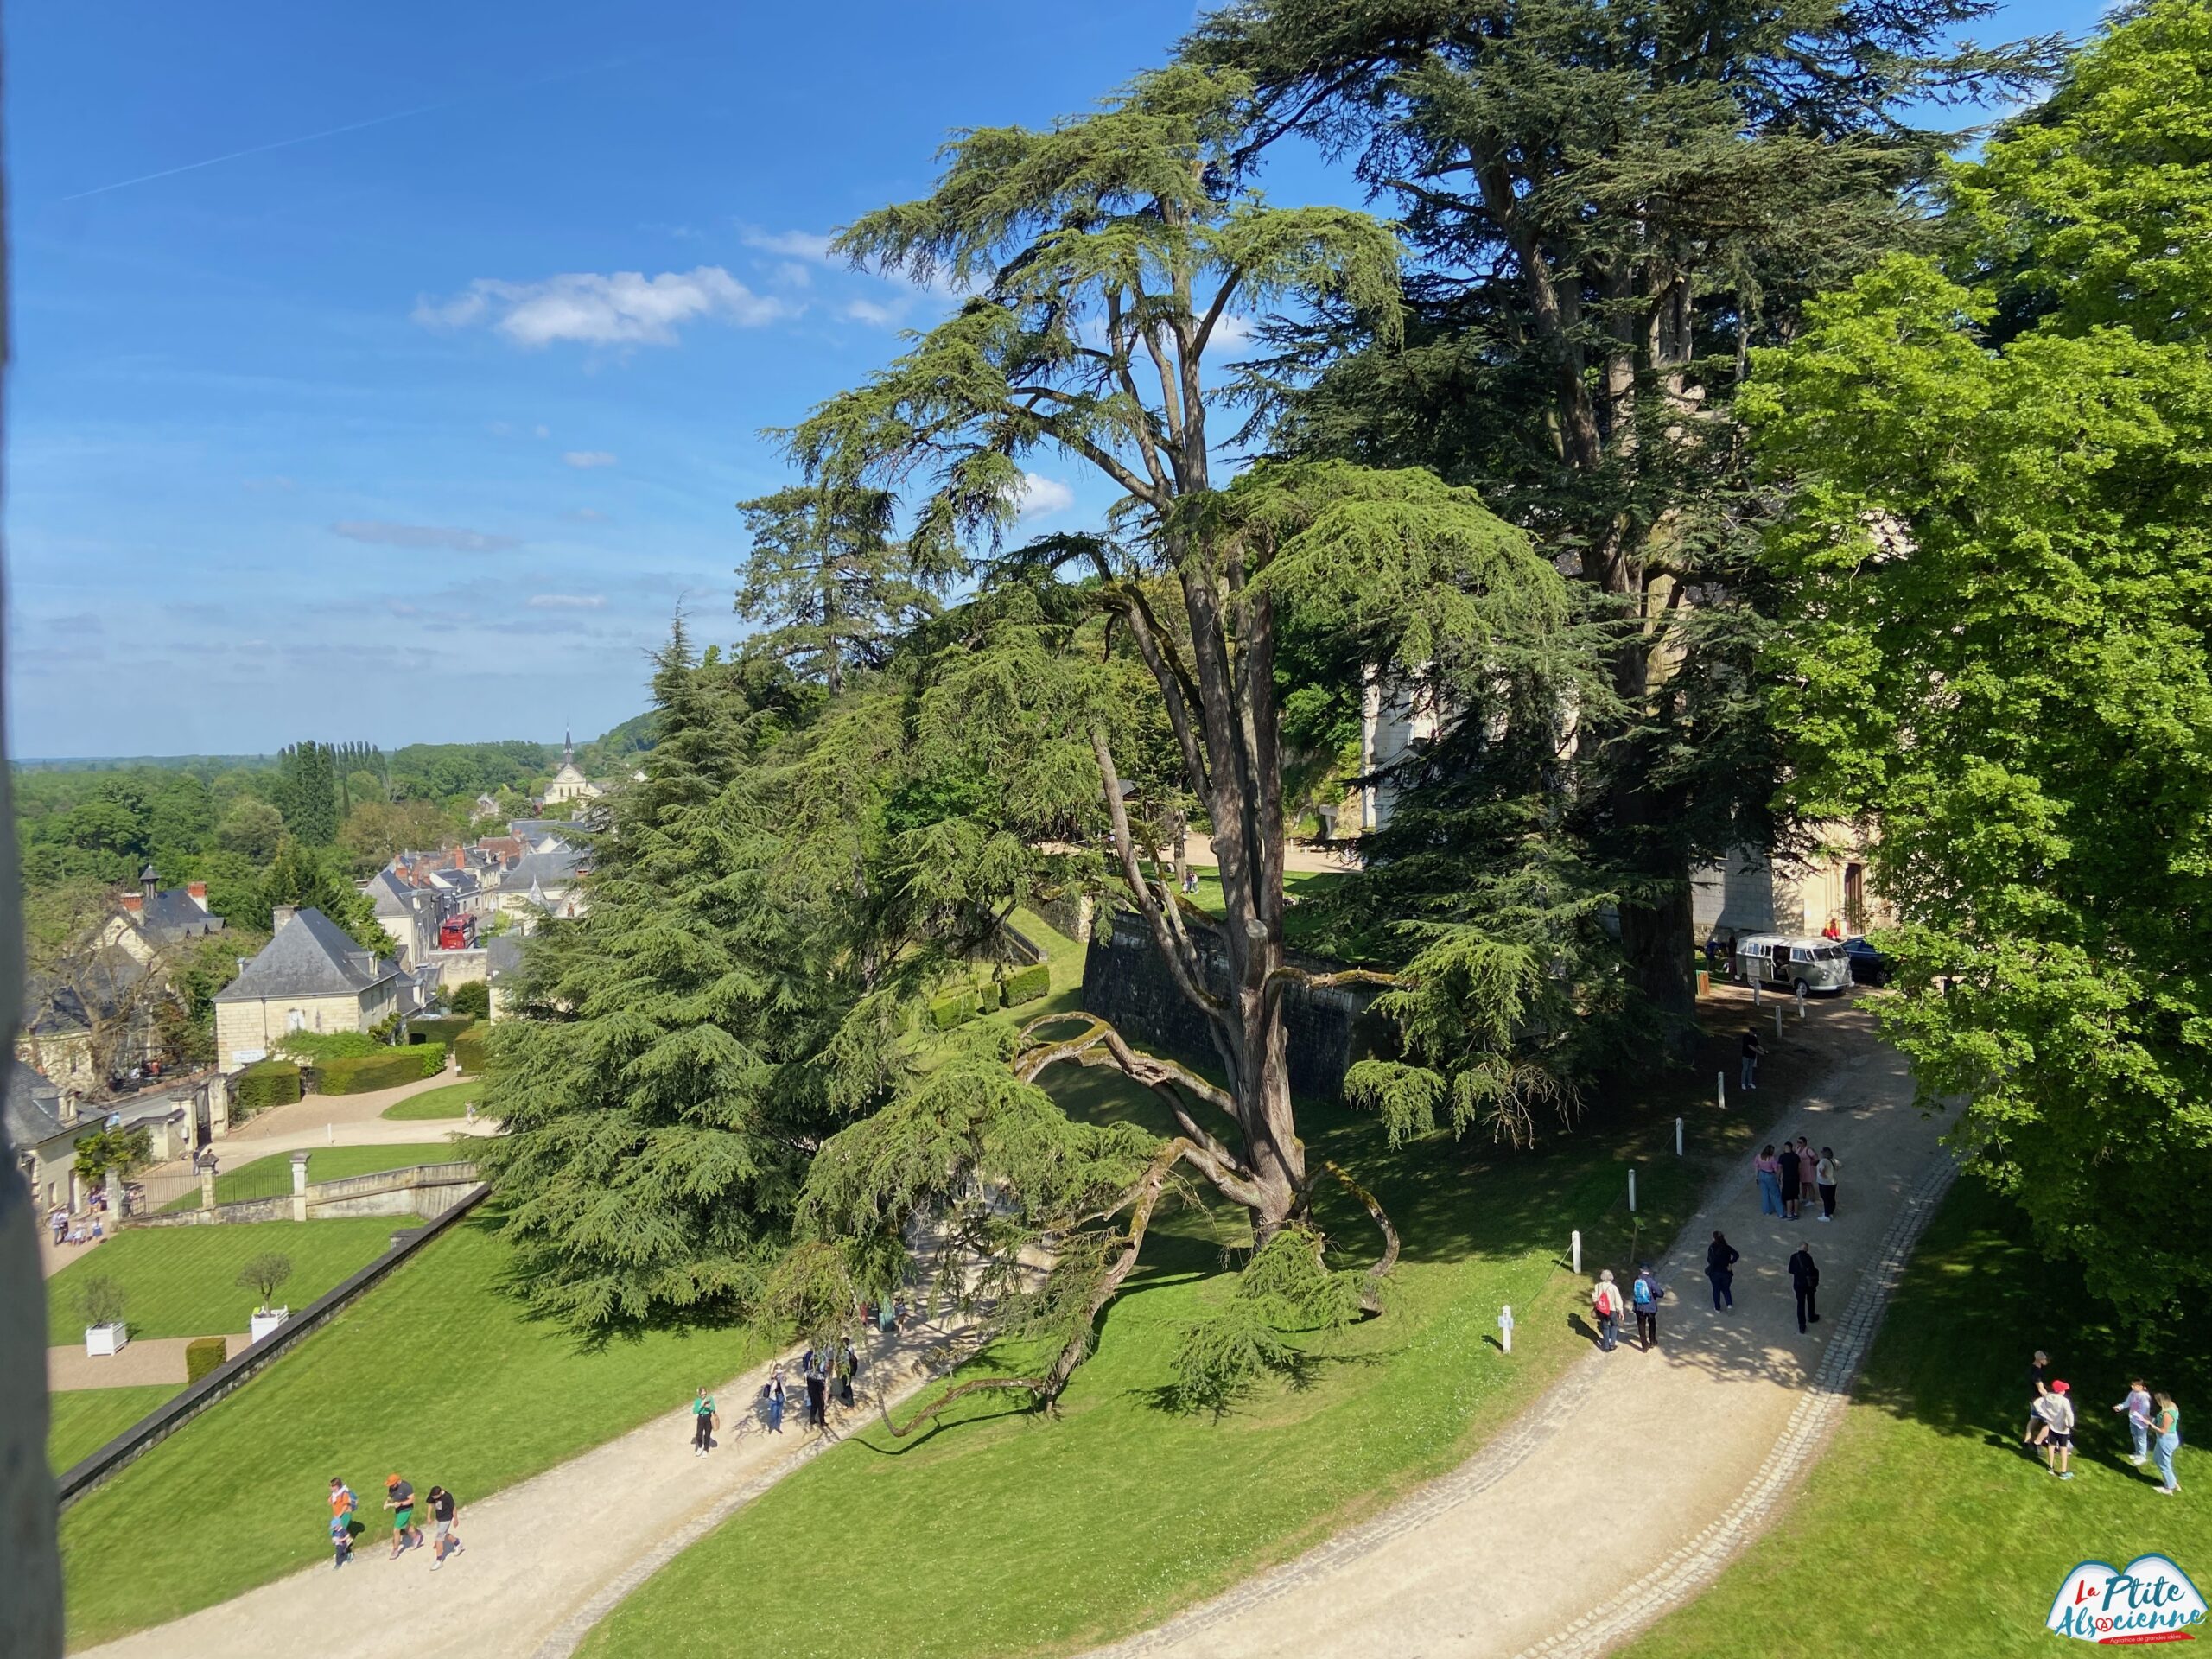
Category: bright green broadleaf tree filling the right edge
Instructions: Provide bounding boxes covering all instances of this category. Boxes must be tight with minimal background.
[1745,0,2212,1320]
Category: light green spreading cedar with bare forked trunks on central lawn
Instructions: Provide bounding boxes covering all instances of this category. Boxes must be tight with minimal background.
[760,68,1564,1402]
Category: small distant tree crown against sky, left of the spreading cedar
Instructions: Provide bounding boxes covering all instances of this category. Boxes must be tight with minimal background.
[736,489,960,696]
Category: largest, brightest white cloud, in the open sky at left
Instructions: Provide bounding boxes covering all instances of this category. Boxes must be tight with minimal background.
[414,265,794,347]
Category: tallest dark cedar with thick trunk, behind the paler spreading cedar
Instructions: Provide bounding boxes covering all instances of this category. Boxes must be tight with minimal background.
[1185,0,2037,1035]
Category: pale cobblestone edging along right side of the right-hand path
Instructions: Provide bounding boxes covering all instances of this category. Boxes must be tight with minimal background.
[1520,1153,1958,1659]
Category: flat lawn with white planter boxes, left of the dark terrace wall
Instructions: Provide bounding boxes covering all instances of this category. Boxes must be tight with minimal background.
[47,1217,410,1353]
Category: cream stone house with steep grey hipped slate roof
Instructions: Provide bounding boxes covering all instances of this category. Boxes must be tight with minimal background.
[214,905,416,1071]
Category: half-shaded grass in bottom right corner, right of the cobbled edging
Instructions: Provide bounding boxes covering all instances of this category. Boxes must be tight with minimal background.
[1628,1181,2212,1659]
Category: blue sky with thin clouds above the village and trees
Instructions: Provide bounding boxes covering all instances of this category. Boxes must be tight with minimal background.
[7,0,2094,757]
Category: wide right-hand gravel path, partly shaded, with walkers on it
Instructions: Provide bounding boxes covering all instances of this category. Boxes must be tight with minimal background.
[1093,1015,1953,1659]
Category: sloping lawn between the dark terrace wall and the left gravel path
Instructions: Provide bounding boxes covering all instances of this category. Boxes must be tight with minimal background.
[62,1217,766,1648]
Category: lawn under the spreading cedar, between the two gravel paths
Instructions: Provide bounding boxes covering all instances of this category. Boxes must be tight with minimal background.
[588,923,1757,1659]
